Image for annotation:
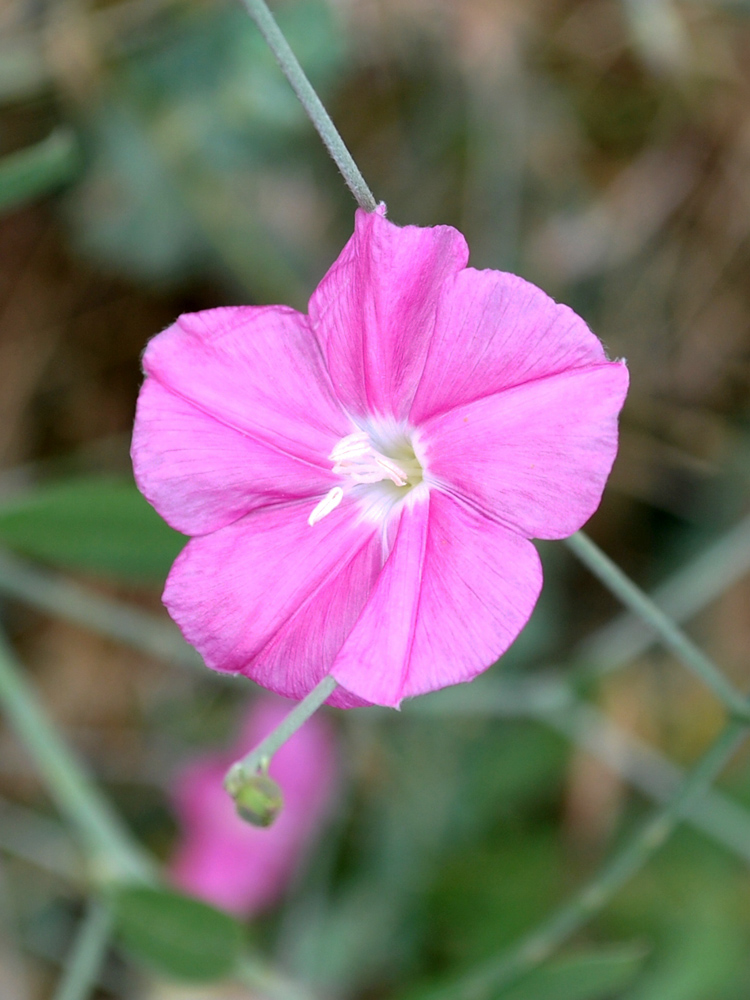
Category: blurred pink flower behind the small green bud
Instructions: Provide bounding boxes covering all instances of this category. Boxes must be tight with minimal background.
[170,696,336,916]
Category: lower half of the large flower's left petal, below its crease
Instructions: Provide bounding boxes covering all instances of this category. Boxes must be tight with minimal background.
[131,377,337,535]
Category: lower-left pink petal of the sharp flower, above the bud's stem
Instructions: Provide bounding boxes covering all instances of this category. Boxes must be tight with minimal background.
[163,500,383,707]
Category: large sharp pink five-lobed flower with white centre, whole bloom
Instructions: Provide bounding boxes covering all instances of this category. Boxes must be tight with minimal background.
[133,208,628,707]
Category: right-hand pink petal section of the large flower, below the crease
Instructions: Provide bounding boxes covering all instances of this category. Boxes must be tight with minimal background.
[420,362,628,538]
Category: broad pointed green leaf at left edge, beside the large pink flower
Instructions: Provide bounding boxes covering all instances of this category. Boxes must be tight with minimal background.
[0,476,185,582]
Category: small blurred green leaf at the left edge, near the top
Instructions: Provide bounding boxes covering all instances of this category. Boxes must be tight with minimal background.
[0,128,81,212]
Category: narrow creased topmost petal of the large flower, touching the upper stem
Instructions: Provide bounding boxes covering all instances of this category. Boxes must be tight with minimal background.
[310,210,469,419]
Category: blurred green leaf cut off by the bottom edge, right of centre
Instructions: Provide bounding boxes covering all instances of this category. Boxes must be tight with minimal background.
[497,946,645,1000]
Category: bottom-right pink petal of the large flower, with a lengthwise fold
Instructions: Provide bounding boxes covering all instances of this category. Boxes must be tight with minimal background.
[331,490,542,707]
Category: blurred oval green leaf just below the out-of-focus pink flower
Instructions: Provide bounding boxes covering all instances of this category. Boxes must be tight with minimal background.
[114,886,243,982]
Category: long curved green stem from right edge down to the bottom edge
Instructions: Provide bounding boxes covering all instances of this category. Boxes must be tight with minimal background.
[425,721,747,1000]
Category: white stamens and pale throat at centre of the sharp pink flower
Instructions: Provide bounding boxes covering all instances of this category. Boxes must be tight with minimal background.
[307,431,423,525]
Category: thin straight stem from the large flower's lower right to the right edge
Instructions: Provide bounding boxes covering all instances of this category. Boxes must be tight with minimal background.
[565,531,750,721]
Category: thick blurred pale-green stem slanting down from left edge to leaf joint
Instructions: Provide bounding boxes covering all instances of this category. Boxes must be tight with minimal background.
[0,636,154,880]
